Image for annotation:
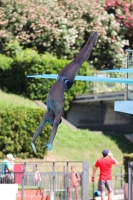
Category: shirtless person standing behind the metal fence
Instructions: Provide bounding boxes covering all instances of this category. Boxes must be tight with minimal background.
[69,166,81,200]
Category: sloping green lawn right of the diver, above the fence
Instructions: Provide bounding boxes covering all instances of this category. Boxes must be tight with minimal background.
[51,124,133,165]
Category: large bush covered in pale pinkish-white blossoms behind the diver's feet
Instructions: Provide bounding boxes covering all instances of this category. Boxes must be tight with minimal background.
[0,0,128,69]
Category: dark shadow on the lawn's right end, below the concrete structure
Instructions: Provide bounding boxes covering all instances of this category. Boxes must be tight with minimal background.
[103,133,133,153]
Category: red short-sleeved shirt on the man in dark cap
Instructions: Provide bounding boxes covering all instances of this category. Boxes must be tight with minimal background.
[95,157,115,180]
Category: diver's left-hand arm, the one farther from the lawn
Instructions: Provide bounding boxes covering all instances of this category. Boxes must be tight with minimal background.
[31,113,47,153]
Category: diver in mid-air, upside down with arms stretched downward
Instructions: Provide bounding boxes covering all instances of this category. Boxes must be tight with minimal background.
[31,32,98,152]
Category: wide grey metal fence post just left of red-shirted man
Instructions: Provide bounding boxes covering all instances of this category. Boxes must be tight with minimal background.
[82,161,89,200]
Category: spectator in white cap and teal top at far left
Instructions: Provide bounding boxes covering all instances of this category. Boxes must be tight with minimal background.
[1,154,15,183]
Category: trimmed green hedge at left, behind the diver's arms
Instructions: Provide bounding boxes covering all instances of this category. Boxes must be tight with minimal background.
[0,105,51,159]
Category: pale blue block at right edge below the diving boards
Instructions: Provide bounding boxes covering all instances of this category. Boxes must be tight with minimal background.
[114,100,133,114]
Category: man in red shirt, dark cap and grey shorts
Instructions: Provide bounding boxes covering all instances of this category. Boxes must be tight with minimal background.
[91,149,119,200]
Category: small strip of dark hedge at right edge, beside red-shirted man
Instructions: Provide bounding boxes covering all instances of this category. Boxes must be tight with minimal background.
[123,153,133,183]
